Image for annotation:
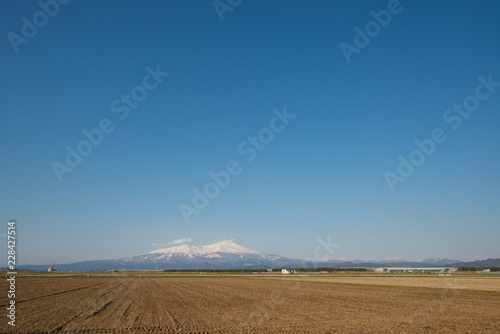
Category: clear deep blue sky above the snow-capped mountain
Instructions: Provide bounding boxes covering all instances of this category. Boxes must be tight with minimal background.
[0,0,500,264]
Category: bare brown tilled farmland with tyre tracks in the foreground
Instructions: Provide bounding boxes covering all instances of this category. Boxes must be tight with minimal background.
[0,276,500,333]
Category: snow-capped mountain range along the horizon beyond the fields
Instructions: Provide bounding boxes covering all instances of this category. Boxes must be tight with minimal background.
[17,240,500,271]
